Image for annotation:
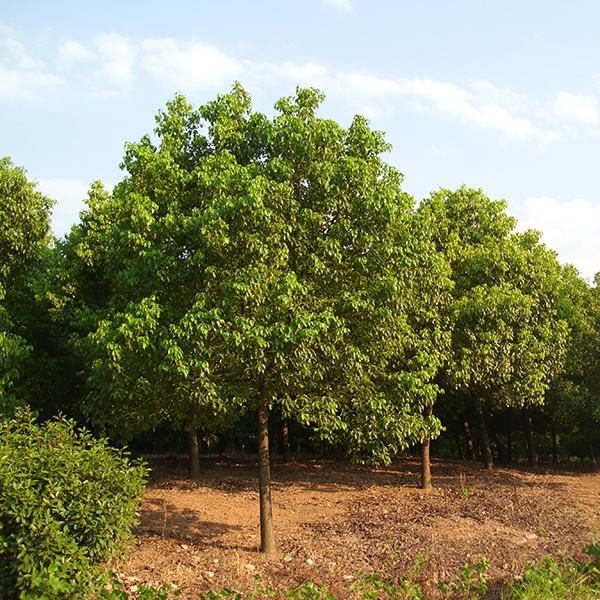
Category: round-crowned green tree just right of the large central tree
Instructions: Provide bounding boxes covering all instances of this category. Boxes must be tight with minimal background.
[420,187,567,468]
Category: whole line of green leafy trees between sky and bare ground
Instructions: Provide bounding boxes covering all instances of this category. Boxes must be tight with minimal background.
[0,84,600,552]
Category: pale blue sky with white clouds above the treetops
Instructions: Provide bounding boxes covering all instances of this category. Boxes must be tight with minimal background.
[0,0,600,279]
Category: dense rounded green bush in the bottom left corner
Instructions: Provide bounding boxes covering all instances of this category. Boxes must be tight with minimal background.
[0,411,147,599]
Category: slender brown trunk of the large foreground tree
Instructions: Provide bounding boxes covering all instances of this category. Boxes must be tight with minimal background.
[258,383,277,554]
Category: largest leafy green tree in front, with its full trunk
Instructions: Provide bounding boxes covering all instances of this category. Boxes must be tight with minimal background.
[76,85,437,552]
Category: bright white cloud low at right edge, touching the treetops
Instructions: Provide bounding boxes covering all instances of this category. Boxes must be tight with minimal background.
[519,197,600,280]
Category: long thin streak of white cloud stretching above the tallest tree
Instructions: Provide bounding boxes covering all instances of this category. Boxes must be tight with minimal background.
[41,31,584,146]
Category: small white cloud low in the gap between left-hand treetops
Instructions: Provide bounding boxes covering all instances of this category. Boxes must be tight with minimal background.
[38,178,89,237]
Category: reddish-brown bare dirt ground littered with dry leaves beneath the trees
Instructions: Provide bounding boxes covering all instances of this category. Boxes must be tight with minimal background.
[117,457,600,599]
